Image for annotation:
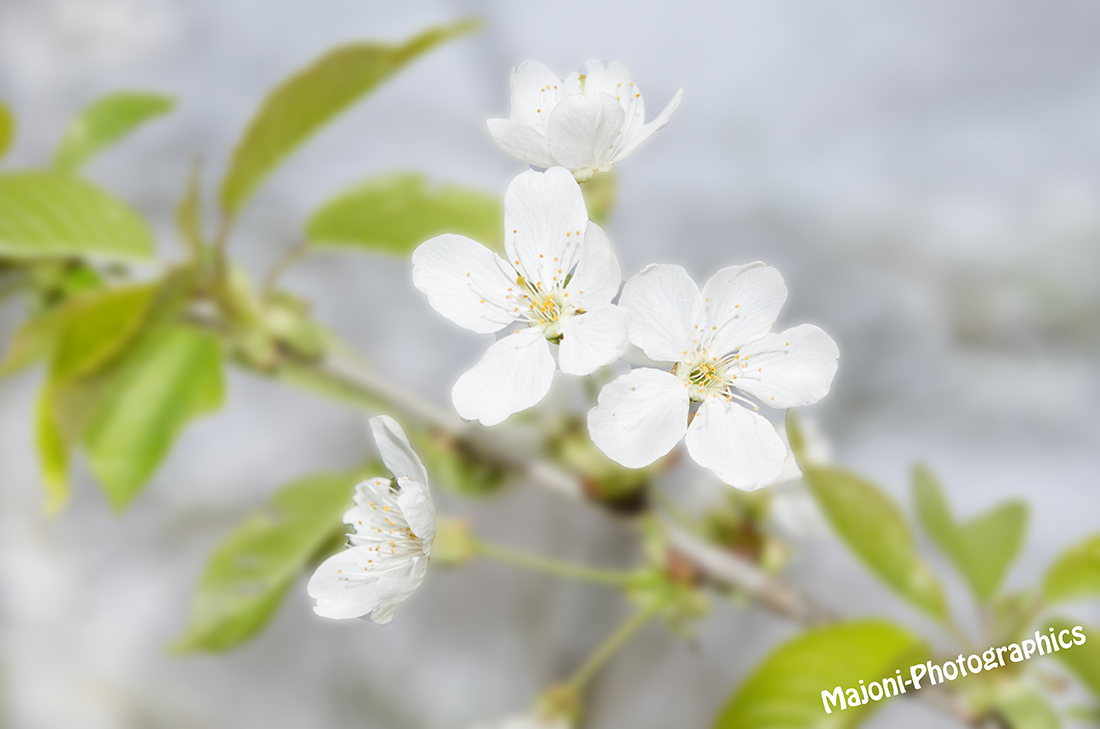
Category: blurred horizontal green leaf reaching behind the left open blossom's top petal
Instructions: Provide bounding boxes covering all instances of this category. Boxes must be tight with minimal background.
[306,174,504,255]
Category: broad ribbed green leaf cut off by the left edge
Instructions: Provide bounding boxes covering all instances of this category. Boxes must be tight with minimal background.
[0,172,153,259]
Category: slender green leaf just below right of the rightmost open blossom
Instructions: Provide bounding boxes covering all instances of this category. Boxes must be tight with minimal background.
[802,464,947,620]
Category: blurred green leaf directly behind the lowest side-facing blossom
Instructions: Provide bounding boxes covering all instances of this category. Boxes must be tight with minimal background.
[172,473,361,653]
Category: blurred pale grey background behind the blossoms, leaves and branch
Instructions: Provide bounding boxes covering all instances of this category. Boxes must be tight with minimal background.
[0,0,1100,729]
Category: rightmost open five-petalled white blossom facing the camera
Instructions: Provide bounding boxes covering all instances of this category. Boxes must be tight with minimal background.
[589,263,838,490]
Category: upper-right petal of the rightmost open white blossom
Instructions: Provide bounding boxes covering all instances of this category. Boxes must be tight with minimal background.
[700,262,787,356]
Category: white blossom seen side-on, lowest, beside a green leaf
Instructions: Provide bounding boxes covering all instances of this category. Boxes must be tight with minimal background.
[307,416,436,625]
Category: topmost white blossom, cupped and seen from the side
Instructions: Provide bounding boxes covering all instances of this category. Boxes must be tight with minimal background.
[488,60,683,183]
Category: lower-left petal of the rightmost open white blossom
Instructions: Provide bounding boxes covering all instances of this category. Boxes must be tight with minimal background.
[589,368,689,468]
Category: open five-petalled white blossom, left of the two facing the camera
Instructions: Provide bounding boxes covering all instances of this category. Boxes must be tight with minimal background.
[413,167,627,426]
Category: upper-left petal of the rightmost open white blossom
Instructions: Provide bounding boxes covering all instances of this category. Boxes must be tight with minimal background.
[619,264,703,362]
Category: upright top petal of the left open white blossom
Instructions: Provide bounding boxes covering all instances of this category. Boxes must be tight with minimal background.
[504,167,589,290]
